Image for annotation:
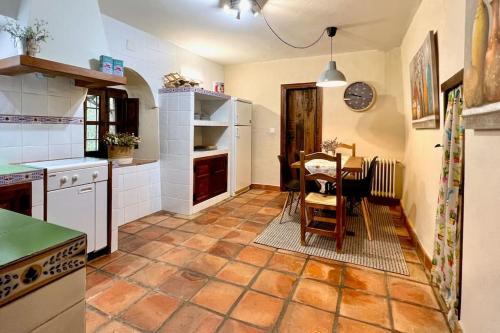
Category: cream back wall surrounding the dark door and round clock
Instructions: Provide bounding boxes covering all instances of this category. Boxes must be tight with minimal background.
[226,49,404,185]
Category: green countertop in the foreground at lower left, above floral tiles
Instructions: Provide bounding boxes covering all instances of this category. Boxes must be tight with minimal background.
[0,209,83,269]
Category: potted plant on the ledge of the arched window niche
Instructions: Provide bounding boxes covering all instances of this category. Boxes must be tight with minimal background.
[103,133,141,164]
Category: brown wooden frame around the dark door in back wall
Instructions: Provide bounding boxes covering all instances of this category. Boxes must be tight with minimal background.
[280,82,323,191]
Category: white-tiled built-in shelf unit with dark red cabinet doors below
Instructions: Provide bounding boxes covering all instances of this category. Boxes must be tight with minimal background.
[159,87,233,215]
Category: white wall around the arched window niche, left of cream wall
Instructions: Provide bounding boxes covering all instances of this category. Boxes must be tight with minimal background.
[102,15,224,159]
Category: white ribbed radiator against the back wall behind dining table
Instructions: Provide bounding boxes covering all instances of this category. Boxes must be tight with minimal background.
[356,158,403,199]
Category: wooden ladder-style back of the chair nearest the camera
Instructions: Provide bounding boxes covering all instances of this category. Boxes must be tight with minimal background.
[300,151,342,207]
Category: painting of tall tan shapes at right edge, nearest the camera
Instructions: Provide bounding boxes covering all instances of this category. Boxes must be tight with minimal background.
[463,0,500,129]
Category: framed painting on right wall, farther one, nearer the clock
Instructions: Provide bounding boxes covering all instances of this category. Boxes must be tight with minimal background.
[410,31,439,128]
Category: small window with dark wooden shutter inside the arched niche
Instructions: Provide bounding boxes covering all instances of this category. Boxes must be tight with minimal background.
[84,89,139,157]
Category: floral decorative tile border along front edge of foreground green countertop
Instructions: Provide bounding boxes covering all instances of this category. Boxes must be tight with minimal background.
[0,235,87,307]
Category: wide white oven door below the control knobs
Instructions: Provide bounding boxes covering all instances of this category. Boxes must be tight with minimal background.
[47,183,96,253]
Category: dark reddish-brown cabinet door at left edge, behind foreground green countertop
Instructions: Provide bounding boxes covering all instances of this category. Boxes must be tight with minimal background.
[0,183,31,216]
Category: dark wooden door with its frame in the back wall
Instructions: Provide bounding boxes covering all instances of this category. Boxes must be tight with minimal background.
[280,82,323,190]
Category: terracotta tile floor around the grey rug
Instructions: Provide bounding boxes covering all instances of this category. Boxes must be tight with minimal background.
[86,190,449,333]
